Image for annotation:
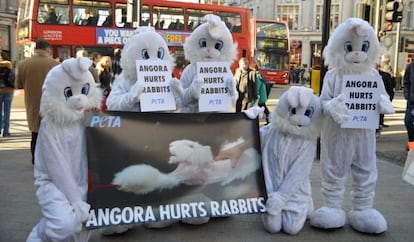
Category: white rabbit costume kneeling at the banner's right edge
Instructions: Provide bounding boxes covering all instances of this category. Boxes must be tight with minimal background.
[260,87,322,234]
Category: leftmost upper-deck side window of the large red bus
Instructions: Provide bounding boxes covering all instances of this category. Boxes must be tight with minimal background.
[37,0,69,24]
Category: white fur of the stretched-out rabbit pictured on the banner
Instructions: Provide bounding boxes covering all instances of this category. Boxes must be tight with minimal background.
[112,139,260,194]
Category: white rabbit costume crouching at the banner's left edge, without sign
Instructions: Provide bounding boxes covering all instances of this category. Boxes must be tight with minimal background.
[27,57,102,241]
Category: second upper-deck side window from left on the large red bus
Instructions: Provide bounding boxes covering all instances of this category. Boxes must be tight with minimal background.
[73,0,111,26]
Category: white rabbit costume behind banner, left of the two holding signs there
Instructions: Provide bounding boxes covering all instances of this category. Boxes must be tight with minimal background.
[106,27,182,112]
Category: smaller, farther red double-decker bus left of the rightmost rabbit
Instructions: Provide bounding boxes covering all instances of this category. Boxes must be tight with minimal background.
[250,19,290,84]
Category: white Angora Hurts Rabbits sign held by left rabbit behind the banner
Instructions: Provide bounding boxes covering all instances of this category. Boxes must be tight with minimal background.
[136,60,176,112]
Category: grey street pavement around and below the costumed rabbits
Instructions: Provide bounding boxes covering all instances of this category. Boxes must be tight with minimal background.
[0,85,414,242]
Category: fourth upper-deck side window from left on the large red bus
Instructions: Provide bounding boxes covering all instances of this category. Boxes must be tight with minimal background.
[152,6,184,30]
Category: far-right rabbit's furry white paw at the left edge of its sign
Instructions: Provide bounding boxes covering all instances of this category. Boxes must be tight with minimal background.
[324,94,351,124]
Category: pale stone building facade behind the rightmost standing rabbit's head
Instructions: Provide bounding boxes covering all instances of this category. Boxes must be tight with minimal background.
[226,0,414,75]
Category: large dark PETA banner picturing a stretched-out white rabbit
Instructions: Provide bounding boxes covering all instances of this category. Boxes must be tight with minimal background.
[85,111,266,229]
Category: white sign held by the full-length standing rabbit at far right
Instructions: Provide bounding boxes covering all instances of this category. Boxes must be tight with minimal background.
[341,75,382,129]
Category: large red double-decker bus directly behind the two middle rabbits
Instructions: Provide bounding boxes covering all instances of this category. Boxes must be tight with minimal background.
[17,0,250,76]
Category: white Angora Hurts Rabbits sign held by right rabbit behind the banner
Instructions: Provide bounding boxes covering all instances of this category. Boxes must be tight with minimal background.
[197,62,233,112]
